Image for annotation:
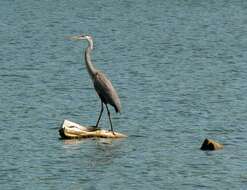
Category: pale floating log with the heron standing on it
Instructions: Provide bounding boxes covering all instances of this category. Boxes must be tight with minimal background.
[59,120,127,139]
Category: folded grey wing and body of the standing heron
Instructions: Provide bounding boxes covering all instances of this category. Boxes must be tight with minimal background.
[94,72,121,112]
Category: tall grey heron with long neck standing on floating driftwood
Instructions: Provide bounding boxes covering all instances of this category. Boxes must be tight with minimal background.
[70,34,121,134]
